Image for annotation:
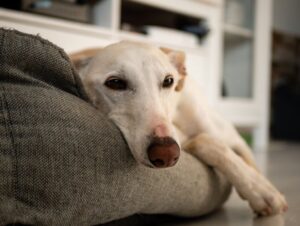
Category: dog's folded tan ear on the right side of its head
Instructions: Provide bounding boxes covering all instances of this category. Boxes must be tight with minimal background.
[160,47,187,91]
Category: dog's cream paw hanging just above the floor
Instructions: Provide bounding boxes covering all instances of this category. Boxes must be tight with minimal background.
[238,172,288,216]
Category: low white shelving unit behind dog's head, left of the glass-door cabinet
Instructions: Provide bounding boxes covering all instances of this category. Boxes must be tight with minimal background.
[0,0,221,99]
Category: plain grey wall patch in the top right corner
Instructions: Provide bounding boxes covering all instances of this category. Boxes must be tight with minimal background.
[274,0,300,35]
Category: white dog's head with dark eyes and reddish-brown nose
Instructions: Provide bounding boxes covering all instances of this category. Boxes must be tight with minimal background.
[76,42,185,168]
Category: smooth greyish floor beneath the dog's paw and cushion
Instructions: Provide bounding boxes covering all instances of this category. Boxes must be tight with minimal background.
[166,142,300,226]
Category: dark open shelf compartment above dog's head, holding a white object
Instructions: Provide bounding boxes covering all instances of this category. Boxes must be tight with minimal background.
[120,0,209,48]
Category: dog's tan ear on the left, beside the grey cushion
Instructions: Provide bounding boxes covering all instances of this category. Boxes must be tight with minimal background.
[69,48,102,72]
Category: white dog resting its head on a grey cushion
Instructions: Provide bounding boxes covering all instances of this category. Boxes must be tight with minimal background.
[70,41,288,216]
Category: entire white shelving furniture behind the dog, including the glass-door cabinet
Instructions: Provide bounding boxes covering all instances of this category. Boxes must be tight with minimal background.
[0,0,272,150]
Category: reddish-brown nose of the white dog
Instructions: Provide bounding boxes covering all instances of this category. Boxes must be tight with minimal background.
[148,137,180,168]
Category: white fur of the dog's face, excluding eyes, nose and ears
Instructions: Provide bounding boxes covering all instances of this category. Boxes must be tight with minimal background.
[83,42,179,166]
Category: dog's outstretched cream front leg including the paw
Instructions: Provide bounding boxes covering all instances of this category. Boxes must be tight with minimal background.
[183,134,287,215]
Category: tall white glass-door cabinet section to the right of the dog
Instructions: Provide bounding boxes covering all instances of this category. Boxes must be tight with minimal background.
[216,0,272,151]
